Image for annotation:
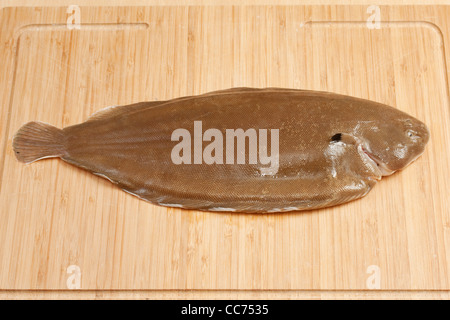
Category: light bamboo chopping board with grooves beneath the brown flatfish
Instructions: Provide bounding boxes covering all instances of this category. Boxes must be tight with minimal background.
[0,6,450,298]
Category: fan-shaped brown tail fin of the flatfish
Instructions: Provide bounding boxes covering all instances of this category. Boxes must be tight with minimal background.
[13,121,66,163]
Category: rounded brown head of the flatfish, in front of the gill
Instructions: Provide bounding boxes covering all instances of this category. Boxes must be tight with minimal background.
[362,115,430,176]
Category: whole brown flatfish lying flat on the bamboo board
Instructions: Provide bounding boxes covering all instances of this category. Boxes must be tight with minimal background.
[13,88,429,213]
